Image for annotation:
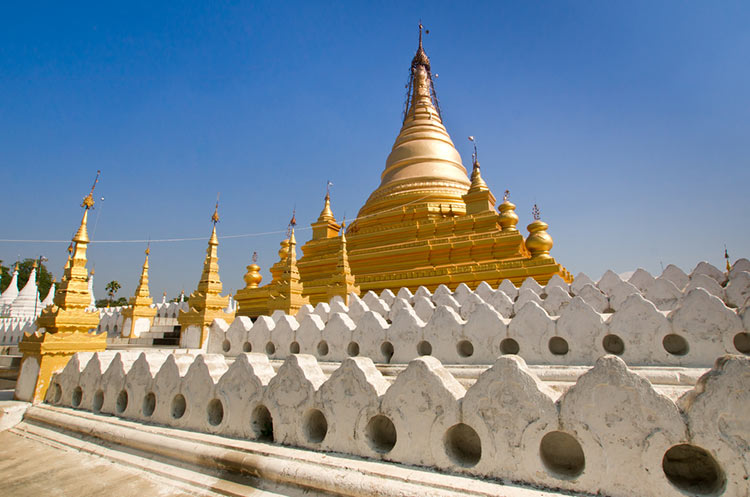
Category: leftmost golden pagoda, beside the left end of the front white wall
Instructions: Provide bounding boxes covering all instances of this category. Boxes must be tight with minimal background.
[15,171,107,402]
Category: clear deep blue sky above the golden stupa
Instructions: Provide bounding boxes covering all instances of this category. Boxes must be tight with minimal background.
[0,0,750,299]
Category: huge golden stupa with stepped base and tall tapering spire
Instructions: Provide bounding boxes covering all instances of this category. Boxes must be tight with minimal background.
[237,25,572,316]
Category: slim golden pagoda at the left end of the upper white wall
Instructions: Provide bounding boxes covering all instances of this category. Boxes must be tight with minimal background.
[177,201,234,348]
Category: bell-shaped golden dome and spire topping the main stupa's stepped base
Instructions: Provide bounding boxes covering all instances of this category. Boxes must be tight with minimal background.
[358,28,471,220]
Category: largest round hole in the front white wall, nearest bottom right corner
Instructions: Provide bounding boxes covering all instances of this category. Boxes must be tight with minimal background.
[661,444,726,495]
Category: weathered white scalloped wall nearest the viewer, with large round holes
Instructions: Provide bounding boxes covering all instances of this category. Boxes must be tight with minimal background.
[47,351,750,497]
